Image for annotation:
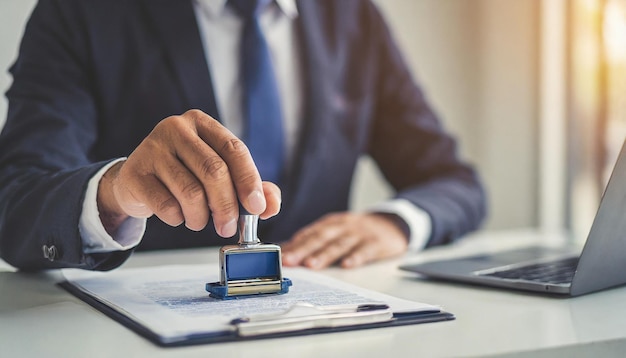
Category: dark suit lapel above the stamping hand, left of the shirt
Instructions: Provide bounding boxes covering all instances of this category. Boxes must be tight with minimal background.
[144,0,219,118]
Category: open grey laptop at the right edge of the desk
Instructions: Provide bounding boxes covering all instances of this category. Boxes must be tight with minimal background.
[400,138,626,297]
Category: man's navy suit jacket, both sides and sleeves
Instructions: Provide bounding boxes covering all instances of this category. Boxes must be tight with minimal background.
[0,0,485,270]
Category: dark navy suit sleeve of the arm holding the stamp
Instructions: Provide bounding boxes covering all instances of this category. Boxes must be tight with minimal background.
[0,0,130,270]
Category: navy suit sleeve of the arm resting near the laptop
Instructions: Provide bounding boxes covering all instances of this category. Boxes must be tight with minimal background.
[369,2,486,246]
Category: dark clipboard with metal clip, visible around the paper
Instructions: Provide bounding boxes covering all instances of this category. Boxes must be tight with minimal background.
[59,269,455,347]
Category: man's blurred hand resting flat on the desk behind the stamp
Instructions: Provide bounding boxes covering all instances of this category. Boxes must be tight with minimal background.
[282,213,408,269]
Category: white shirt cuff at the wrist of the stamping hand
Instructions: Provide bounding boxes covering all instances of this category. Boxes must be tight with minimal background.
[78,158,147,254]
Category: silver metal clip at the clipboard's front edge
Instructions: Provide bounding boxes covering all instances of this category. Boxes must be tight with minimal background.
[231,303,394,337]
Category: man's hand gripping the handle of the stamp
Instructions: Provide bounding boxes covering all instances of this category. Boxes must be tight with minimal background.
[98,110,281,237]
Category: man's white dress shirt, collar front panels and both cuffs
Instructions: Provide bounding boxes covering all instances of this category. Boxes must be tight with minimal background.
[79,0,432,254]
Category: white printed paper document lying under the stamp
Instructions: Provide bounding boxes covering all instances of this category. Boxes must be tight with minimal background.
[63,265,439,343]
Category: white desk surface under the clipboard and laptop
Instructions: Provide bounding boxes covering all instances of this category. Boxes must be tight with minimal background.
[0,231,626,358]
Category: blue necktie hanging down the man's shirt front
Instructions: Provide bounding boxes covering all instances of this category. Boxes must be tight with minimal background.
[229,0,284,183]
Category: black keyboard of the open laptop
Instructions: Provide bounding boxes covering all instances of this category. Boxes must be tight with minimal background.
[482,257,578,284]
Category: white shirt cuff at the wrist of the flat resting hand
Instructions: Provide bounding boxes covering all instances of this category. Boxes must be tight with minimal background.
[368,199,432,251]
